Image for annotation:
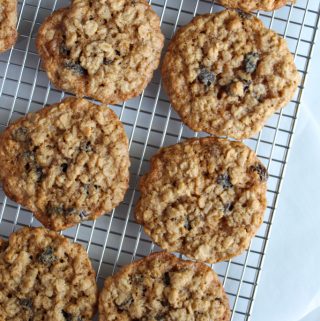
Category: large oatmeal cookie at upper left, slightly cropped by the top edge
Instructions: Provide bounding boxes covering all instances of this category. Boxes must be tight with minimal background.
[37,0,164,104]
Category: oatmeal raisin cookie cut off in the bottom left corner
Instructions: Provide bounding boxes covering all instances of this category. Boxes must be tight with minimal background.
[0,228,98,321]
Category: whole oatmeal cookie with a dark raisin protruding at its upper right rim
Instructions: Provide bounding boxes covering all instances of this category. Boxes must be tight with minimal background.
[136,137,268,263]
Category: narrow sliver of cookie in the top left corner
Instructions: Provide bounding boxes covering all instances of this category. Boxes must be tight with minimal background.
[0,0,17,52]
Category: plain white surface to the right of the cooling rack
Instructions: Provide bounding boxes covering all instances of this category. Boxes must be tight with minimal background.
[251,27,320,321]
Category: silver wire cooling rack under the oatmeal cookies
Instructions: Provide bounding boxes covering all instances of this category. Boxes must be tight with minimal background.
[0,0,320,321]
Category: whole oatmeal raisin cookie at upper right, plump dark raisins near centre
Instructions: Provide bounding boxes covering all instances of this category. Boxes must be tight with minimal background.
[162,10,299,139]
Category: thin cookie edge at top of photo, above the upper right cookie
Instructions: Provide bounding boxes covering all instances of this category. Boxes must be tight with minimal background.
[218,0,295,12]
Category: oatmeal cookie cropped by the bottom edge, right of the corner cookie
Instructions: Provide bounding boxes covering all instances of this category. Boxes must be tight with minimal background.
[99,252,230,321]
